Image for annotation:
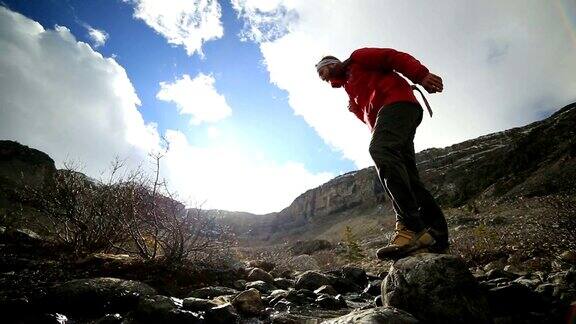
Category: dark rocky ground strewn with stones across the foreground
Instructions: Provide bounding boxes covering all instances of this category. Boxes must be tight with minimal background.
[0,218,576,323]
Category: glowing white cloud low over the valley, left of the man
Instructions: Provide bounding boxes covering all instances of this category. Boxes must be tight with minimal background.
[164,130,334,214]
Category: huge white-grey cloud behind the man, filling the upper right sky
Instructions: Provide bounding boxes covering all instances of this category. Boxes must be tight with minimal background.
[232,0,576,167]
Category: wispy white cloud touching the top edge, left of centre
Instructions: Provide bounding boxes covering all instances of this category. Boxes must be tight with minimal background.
[124,0,224,56]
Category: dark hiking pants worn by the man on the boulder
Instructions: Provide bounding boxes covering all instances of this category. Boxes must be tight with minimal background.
[369,102,448,246]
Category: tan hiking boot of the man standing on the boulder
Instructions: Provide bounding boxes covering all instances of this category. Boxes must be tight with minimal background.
[376,222,436,260]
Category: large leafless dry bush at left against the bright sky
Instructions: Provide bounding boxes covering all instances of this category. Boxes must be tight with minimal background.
[23,154,235,265]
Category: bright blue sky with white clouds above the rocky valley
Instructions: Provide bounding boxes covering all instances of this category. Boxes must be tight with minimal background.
[0,0,576,214]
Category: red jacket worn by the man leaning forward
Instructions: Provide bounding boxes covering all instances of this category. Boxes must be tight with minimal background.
[344,48,428,131]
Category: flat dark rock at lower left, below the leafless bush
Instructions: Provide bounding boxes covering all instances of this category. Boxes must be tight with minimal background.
[46,278,156,313]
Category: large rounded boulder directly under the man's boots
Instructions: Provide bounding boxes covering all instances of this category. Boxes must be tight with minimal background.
[382,253,492,323]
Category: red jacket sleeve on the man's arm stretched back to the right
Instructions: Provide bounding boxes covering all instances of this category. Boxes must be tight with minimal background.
[350,48,429,83]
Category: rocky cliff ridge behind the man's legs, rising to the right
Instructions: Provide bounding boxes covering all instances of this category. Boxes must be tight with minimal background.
[220,103,576,239]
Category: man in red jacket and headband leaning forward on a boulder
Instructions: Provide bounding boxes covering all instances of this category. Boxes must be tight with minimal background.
[316,48,448,259]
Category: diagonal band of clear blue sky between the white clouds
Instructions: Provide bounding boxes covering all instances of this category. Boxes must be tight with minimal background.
[4,0,356,174]
